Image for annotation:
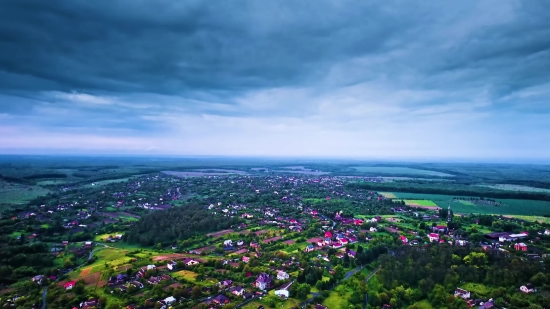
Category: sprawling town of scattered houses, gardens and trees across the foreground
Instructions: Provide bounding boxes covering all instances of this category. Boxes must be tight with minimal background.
[1,173,550,309]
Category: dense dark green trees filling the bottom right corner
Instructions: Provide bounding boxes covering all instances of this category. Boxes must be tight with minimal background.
[369,245,550,309]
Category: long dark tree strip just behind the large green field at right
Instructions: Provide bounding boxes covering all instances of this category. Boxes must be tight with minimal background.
[347,181,550,201]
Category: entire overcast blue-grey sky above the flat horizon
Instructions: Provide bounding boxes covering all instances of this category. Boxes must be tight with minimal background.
[0,0,550,160]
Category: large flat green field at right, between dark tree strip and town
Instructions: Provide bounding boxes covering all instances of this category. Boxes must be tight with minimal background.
[392,192,550,215]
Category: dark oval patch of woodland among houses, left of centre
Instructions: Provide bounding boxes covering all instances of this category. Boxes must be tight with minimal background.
[125,204,239,246]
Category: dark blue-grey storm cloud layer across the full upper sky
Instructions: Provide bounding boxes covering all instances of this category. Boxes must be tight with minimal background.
[0,0,550,101]
